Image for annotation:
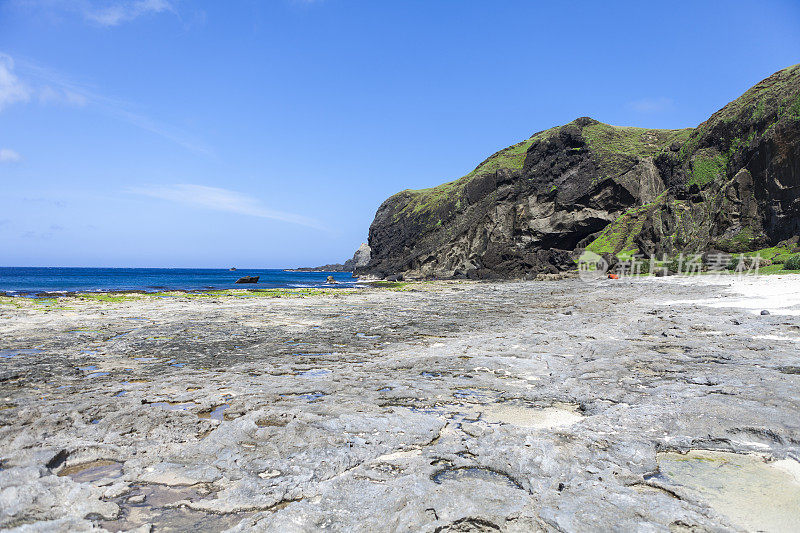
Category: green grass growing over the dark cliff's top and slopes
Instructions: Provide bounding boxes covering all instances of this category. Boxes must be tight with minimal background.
[382,65,800,252]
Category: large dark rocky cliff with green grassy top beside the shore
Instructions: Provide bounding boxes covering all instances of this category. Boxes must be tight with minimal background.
[356,65,800,279]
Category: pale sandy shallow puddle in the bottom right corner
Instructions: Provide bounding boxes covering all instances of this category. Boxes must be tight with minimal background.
[657,450,800,532]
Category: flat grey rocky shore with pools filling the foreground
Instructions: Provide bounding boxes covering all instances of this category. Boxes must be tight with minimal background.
[0,275,800,532]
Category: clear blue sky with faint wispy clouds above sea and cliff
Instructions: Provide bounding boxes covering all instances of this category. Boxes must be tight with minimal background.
[0,0,800,268]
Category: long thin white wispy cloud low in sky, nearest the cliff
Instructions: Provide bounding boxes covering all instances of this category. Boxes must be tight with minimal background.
[128,183,326,230]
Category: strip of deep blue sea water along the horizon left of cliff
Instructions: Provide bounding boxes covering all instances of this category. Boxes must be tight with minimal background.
[0,267,356,296]
